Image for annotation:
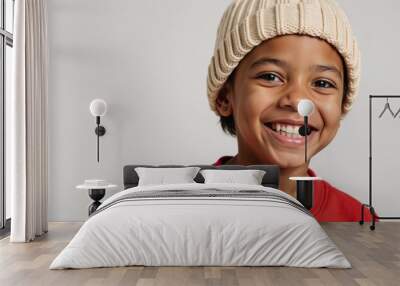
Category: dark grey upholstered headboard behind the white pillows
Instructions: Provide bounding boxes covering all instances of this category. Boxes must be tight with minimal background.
[124,165,279,189]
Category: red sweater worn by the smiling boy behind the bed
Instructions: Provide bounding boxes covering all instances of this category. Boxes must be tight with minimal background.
[213,156,371,222]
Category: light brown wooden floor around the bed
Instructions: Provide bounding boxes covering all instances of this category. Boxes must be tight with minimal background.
[0,222,400,286]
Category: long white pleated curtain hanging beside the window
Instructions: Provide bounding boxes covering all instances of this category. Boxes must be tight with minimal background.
[6,0,48,242]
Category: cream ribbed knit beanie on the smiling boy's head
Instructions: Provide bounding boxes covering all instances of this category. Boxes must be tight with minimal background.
[207,0,360,115]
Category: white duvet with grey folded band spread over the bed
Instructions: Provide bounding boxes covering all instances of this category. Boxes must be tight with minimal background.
[50,183,351,269]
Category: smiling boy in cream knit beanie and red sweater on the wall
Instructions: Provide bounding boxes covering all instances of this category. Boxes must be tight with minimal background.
[207,0,370,221]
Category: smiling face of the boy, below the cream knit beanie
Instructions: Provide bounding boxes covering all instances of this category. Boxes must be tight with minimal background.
[217,35,344,168]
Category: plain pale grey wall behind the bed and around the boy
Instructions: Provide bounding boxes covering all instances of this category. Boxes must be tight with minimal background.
[48,0,400,221]
